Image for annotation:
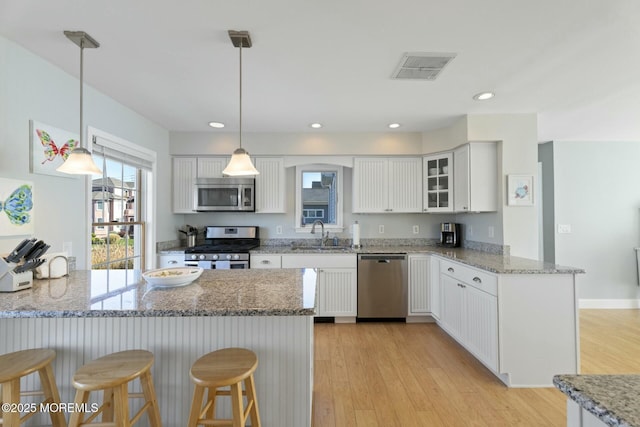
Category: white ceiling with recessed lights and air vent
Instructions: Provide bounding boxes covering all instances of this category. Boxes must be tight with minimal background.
[0,0,640,141]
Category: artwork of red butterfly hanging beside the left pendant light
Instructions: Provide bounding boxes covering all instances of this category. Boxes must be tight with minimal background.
[29,120,78,178]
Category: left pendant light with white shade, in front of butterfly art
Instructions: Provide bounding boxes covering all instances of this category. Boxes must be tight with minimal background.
[56,31,102,175]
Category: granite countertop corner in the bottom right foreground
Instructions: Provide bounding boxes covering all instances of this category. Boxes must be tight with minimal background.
[553,375,640,427]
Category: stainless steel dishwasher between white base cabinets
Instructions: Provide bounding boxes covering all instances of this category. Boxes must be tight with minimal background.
[358,254,408,318]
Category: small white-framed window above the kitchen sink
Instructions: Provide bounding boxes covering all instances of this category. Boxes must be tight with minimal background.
[296,165,342,233]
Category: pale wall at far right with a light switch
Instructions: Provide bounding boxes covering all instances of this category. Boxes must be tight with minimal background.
[553,141,640,306]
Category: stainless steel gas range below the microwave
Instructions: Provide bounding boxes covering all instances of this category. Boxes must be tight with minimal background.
[184,226,260,270]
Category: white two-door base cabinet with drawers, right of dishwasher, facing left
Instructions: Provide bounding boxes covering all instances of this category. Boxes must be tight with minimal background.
[440,261,499,372]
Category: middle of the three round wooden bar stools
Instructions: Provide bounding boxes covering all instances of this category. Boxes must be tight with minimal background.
[69,350,162,427]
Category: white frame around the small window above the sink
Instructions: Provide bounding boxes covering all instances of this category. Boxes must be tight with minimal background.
[294,163,344,233]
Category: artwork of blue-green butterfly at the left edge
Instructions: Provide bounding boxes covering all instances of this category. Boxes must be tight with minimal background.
[0,178,35,236]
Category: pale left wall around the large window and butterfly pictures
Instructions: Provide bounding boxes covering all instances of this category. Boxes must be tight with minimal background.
[0,37,177,268]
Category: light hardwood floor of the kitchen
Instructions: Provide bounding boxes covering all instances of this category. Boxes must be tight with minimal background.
[313,310,640,427]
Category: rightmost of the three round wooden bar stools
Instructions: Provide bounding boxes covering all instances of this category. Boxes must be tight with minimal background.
[187,348,260,427]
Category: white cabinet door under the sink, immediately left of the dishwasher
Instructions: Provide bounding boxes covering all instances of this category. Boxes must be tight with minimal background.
[318,268,358,317]
